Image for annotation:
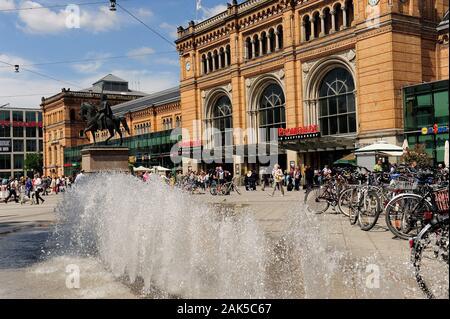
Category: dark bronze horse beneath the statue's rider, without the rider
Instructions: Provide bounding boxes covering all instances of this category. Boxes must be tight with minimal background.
[80,102,131,145]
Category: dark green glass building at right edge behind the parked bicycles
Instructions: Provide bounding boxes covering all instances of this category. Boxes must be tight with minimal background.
[403,80,449,164]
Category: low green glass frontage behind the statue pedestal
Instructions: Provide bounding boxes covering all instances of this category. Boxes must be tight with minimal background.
[64,130,181,176]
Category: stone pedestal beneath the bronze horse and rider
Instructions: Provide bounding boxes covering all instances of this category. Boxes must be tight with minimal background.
[81,145,129,174]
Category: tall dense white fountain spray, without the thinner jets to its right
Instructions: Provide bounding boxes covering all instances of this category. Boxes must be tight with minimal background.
[50,174,266,298]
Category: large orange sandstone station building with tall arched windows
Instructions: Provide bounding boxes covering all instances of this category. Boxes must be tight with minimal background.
[176,0,449,173]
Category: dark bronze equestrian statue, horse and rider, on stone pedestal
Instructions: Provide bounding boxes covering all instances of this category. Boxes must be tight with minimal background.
[80,90,131,145]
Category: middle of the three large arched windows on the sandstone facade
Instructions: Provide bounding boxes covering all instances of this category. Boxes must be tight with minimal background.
[258,83,286,141]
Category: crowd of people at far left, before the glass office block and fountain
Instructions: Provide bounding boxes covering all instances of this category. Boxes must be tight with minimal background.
[0,174,73,205]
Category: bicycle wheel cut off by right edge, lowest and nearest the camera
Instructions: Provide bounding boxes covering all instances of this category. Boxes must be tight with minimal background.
[411,223,449,299]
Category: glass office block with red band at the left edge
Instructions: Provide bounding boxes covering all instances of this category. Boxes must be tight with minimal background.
[0,108,42,178]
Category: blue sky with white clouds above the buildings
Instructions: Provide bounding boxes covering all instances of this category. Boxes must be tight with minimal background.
[0,0,230,108]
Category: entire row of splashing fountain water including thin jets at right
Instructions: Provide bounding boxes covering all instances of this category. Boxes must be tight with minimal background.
[39,174,432,298]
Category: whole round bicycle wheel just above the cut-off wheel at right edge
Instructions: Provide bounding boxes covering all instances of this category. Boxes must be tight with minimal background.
[386,194,432,239]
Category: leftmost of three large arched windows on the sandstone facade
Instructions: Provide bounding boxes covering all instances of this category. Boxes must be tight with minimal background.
[211,95,233,146]
